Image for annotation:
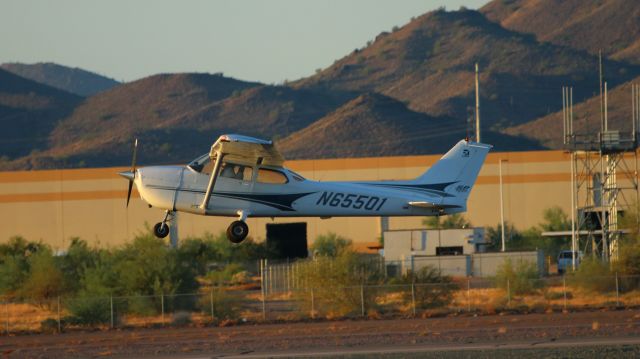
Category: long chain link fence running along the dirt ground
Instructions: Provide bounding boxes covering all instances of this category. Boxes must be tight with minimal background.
[0,274,640,335]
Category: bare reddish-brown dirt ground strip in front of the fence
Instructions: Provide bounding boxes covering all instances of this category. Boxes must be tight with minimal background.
[0,310,640,358]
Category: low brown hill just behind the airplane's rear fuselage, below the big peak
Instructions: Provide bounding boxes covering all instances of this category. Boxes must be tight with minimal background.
[277,93,541,159]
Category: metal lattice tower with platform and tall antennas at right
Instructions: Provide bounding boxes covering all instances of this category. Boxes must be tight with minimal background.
[562,82,640,264]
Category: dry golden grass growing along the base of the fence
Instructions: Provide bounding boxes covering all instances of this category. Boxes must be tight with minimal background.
[5,286,640,332]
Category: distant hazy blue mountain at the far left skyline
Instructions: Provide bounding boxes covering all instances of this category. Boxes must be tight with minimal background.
[0,62,119,97]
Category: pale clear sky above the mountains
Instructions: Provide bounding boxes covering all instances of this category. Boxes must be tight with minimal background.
[0,0,487,84]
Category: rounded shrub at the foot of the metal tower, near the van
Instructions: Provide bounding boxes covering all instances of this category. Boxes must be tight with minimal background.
[568,257,616,292]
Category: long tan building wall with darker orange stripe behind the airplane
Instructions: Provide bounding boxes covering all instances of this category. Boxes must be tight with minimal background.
[0,151,620,248]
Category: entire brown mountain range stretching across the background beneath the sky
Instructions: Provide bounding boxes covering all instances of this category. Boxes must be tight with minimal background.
[0,0,640,169]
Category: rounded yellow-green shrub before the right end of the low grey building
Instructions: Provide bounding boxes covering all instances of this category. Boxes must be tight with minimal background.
[495,259,544,295]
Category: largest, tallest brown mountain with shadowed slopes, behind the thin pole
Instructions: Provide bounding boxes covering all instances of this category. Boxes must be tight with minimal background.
[295,10,640,129]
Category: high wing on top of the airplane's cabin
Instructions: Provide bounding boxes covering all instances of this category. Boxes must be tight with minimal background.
[209,134,284,167]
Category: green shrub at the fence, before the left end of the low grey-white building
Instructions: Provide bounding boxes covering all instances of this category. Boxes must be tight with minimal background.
[402,266,458,309]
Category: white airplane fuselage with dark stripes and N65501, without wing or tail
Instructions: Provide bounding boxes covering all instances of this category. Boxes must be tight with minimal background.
[135,166,462,217]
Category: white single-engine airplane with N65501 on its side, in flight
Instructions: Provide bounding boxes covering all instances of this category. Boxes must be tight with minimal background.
[119,134,492,243]
